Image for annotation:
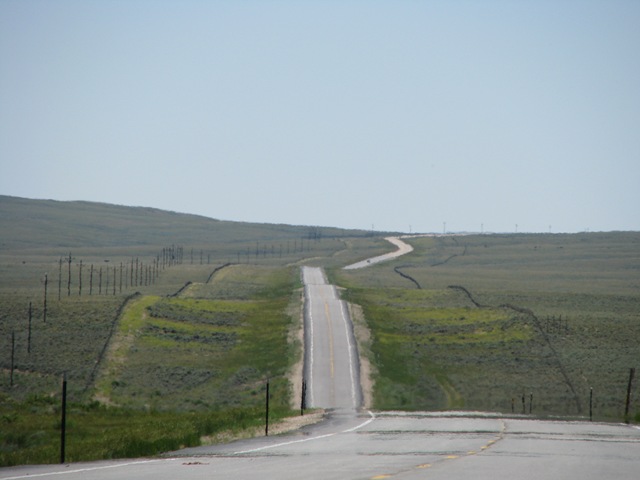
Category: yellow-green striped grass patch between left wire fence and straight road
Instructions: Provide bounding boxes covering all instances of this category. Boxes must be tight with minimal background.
[92,266,299,410]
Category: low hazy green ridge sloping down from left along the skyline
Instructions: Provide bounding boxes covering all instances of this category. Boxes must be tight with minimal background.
[0,195,370,250]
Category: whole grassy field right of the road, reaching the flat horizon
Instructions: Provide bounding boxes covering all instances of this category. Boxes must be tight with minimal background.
[332,233,640,420]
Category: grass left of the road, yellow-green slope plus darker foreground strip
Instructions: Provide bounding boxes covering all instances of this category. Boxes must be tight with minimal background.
[0,265,300,465]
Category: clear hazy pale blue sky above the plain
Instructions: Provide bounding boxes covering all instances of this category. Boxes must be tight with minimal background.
[0,0,640,232]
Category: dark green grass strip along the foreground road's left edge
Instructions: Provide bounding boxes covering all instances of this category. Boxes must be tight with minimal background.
[0,397,290,466]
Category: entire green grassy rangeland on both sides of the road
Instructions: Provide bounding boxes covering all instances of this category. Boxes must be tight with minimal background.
[0,196,640,465]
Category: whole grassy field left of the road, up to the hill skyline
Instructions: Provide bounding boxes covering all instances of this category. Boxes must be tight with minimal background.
[0,196,387,465]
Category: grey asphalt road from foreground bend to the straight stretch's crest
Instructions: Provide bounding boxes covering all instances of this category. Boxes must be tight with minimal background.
[0,268,640,480]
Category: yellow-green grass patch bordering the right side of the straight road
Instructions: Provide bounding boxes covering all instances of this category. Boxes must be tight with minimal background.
[350,289,540,410]
